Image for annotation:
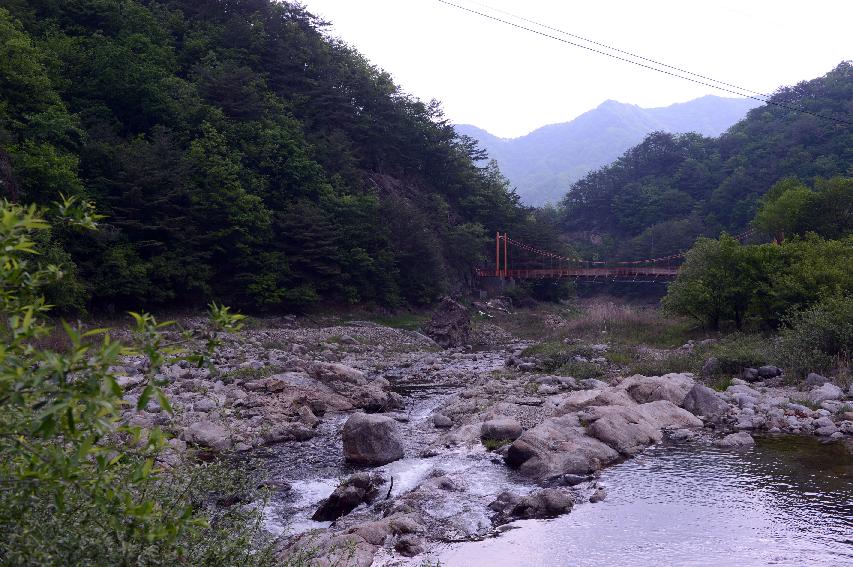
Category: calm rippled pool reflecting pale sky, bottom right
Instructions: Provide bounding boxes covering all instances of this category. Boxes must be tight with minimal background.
[440,438,853,567]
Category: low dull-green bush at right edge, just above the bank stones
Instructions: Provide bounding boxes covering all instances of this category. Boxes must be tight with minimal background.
[777,295,853,378]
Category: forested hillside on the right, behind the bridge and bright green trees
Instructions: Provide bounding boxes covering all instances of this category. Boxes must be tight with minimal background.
[561,62,853,257]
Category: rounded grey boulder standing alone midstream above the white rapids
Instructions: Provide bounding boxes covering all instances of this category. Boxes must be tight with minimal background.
[342,413,403,466]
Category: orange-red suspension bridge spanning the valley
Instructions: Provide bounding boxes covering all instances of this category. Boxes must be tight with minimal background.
[477,230,754,283]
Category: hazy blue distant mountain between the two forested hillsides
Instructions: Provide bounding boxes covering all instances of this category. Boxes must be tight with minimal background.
[456,95,759,205]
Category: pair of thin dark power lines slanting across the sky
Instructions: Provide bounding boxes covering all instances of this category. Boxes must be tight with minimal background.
[437,0,853,126]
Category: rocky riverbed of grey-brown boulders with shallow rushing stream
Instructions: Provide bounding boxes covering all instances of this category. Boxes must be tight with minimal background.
[111,303,853,566]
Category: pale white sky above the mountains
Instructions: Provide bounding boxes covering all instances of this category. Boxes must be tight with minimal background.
[302,0,853,138]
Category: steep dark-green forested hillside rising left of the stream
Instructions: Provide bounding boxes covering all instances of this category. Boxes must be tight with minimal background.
[0,0,548,309]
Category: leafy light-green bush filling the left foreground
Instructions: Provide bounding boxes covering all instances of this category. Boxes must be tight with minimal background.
[0,200,271,565]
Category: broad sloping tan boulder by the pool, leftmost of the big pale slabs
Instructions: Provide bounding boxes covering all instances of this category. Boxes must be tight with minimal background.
[506,414,619,480]
